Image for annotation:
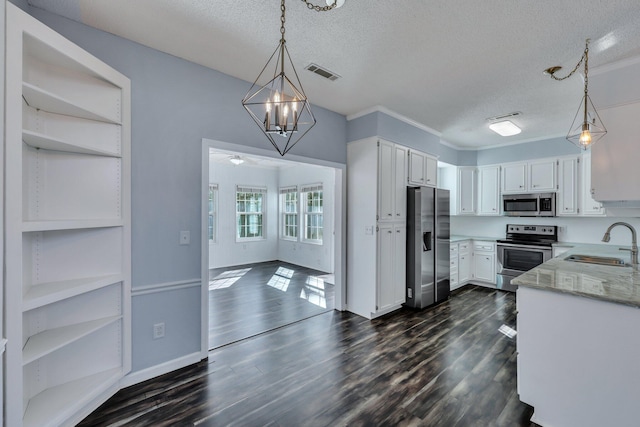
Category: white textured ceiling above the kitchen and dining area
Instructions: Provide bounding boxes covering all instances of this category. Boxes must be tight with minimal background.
[29,0,640,148]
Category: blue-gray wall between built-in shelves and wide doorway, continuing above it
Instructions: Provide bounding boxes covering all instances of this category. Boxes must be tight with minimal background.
[29,8,346,371]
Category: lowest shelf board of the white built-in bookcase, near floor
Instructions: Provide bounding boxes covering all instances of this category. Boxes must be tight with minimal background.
[22,368,123,427]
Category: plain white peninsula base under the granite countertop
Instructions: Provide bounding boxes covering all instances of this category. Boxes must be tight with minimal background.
[516,288,640,427]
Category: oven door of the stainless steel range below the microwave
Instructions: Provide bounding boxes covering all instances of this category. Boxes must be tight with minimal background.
[496,243,552,291]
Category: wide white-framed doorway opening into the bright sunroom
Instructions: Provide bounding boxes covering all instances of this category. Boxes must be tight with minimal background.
[202,140,344,351]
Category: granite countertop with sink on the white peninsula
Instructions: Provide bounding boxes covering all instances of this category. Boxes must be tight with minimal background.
[512,243,640,308]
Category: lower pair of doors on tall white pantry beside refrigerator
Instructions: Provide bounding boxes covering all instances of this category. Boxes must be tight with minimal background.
[376,223,407,311]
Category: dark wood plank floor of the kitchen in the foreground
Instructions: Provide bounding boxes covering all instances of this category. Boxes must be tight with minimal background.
[81,286,535,427]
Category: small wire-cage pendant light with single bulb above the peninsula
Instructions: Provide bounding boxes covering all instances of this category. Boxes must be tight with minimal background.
[544,39,607,150]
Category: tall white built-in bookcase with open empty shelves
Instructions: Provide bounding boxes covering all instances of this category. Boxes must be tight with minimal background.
[4,3,131,427]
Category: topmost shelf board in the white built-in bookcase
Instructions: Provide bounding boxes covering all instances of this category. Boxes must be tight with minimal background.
[22,82,121,125]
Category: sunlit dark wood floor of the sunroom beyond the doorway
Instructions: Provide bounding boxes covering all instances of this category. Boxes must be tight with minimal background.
[209,261,335,349]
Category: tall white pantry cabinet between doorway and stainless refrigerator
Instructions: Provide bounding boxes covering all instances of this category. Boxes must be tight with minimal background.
[347,138,408,319]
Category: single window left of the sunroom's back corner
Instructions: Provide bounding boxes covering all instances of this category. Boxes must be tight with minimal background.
[236,185,267,241]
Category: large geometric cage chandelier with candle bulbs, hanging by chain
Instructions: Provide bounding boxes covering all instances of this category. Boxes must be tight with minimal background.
[242,0,338,156]
